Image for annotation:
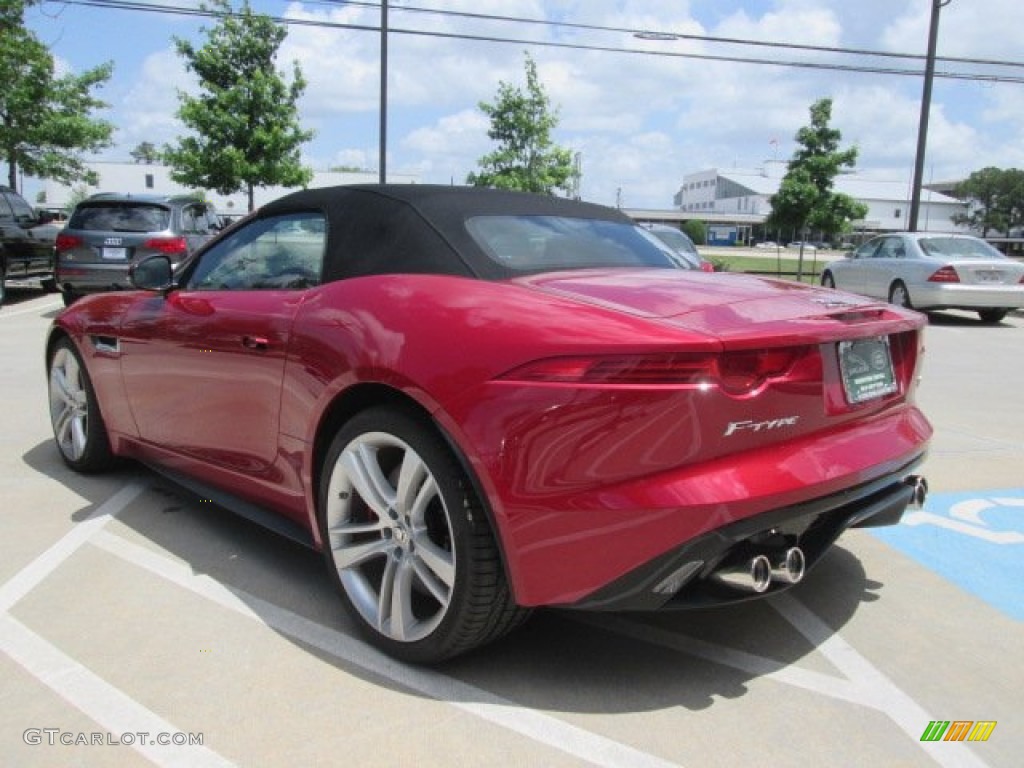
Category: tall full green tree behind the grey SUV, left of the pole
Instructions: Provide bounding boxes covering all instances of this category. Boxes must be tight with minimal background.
[163,0,313,211]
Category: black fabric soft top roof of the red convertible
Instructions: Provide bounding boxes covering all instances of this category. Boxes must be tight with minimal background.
[258,184,631,281]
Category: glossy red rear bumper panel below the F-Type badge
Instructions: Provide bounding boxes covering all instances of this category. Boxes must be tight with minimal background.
[496,406,932,606]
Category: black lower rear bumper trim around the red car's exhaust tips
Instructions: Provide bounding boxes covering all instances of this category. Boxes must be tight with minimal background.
[563,455,924,611]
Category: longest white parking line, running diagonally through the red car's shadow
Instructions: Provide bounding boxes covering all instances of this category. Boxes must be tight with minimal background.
[91,530,677,768]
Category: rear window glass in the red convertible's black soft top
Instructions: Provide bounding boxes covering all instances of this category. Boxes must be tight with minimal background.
[466,216,678,272]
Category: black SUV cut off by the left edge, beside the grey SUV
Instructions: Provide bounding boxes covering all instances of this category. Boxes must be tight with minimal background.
[0,186,53,305]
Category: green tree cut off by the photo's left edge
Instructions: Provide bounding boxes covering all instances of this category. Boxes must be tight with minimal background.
[0,0,114,187]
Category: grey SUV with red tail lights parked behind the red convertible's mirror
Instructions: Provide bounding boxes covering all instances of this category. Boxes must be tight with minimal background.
[56,194,221,304]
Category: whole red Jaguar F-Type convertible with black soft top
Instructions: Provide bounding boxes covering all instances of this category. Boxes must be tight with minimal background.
[46,185,931,663]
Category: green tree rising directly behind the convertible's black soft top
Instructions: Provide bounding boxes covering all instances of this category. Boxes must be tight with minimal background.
[466,53,575,195]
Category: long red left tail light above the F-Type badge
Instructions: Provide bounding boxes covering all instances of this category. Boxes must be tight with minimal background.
[500,347,820,395]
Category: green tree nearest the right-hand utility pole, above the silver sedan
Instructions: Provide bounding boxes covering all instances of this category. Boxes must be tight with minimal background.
[765,98,867,279]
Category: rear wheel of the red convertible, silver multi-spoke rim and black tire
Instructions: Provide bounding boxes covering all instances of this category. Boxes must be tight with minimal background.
[318,407,528,664]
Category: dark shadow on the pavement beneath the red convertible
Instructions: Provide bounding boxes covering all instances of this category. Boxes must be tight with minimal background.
[24,441,884,714]
